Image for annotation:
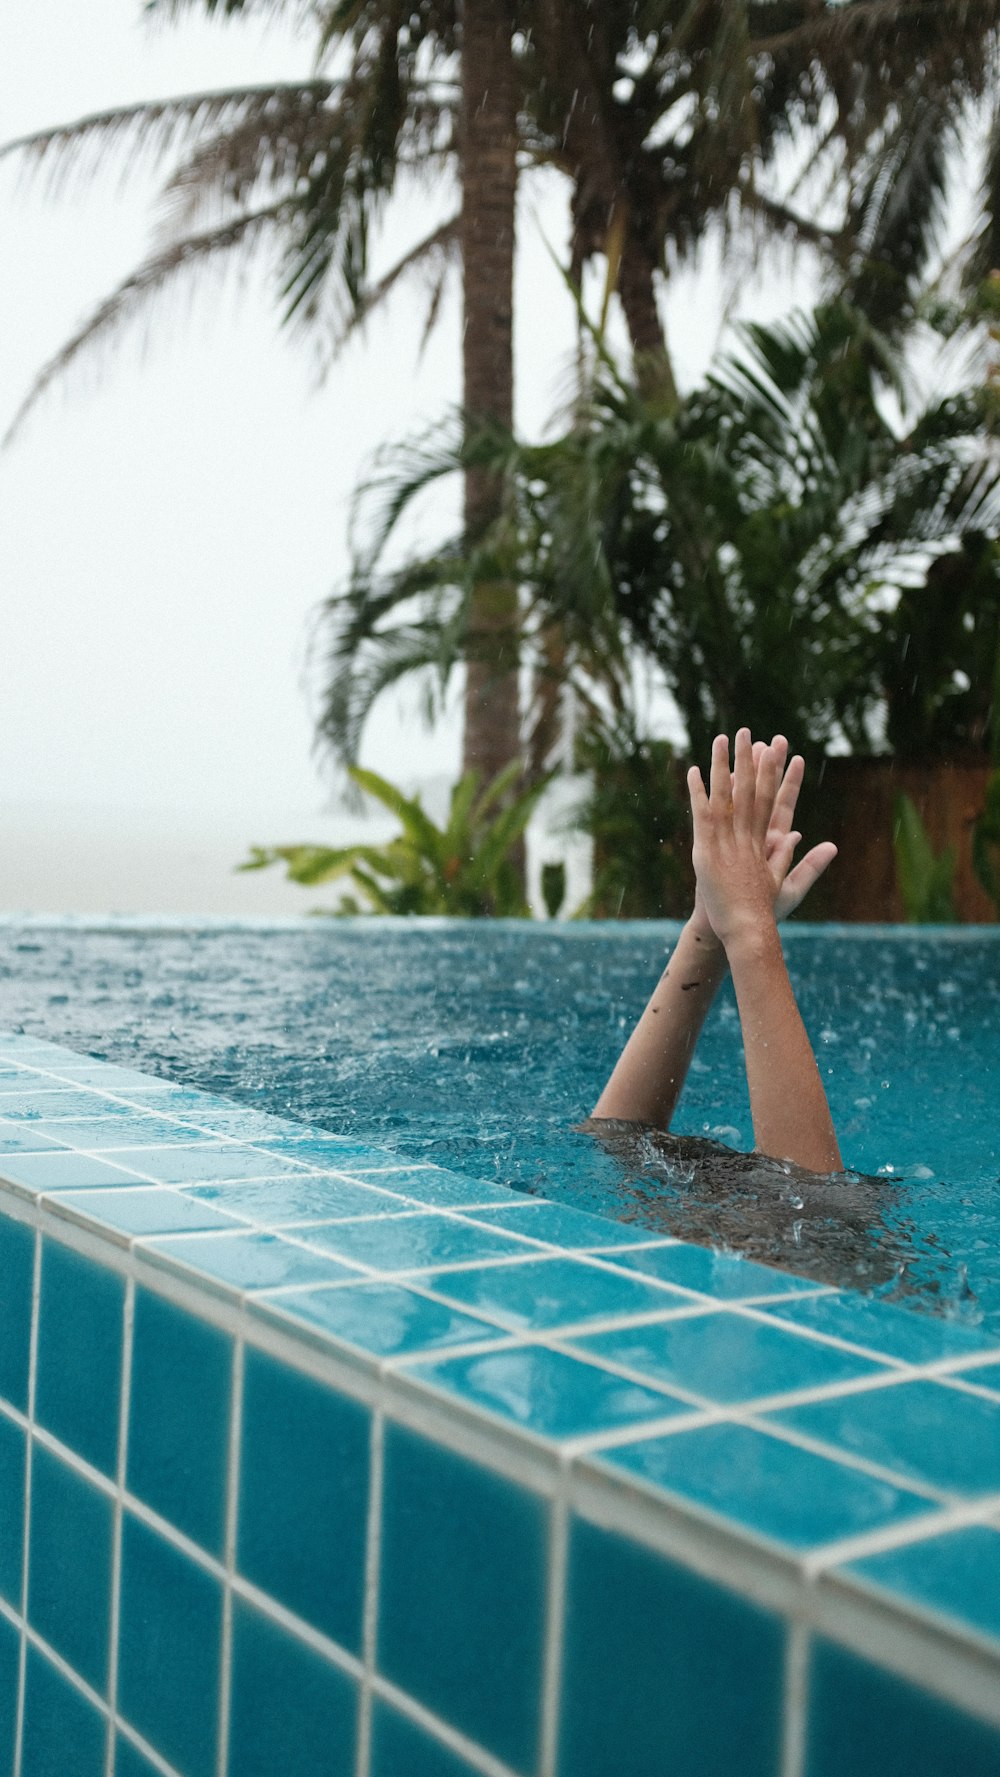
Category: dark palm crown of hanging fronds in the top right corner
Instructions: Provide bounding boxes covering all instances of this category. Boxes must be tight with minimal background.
[524,0,1000,403]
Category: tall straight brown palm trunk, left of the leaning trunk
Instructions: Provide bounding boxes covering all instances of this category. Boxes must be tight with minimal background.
[462,0,520,782]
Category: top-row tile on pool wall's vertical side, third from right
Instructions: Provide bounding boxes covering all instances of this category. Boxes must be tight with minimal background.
[378,1425,549,1772]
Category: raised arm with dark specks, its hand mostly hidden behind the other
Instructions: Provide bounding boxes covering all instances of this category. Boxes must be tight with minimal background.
[593,734,837,1128]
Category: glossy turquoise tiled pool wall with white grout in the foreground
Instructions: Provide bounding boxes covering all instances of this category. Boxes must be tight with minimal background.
[0,1038,1000,1777]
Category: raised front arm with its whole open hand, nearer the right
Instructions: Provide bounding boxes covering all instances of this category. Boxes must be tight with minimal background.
[687,729,842,1173]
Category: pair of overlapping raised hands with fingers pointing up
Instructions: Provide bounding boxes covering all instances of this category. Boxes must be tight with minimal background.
[687,729,837,949]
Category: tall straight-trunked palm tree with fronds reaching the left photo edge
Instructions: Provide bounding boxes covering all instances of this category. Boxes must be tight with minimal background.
[5,0,520,778]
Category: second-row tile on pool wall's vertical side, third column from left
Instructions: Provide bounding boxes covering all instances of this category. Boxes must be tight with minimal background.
[119,1512,222,1777]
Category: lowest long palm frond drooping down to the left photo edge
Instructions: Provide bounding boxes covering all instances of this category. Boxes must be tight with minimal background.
[4,203,288,444]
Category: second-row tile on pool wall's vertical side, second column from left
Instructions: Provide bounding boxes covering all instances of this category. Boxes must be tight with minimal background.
[28,1443,114,1693]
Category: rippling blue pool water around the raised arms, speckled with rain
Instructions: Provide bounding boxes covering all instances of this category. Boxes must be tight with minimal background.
[0,920,1000,1327]
